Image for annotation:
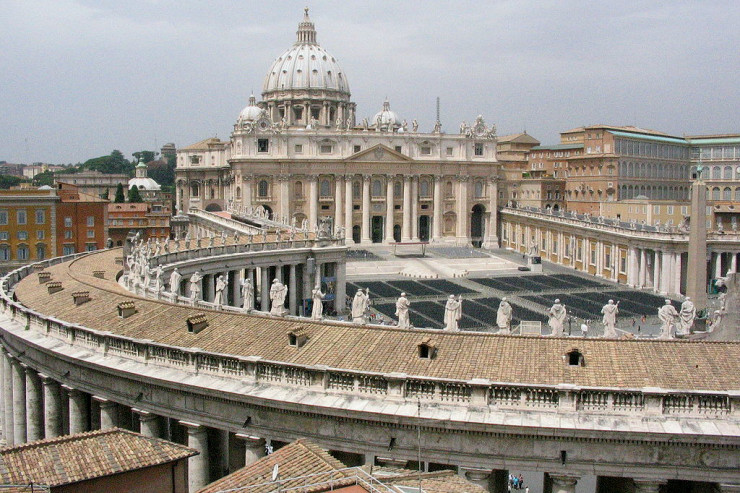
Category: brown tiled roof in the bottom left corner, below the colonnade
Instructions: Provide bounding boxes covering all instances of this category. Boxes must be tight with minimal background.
[0,428,198,486]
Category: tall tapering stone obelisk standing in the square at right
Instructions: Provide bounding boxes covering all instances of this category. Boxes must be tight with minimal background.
[686,165,707,320]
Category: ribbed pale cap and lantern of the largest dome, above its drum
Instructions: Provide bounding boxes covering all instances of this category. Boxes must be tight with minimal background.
[262,9,350,99]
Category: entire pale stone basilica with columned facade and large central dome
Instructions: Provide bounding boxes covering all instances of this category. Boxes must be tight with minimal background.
[176,7,499,247]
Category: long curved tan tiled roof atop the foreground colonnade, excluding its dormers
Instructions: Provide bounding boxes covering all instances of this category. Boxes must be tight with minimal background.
[15,249,740,391]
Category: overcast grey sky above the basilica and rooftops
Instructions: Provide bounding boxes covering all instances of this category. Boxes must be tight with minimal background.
[0,0,740,163]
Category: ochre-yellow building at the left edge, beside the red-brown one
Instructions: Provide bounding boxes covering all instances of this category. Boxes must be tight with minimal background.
[0,189,59,271]
